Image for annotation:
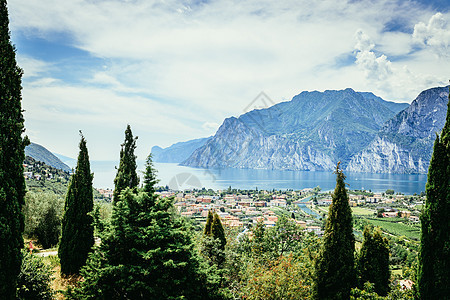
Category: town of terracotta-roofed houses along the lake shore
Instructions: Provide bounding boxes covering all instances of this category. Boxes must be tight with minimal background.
[97,187,424,236]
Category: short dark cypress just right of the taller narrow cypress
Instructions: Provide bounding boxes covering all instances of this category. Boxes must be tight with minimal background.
[358,226,391,296]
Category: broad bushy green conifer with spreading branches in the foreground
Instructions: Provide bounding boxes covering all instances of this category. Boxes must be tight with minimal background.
[69,156,215,299]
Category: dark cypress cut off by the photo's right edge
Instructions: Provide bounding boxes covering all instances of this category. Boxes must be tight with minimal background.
[418,88,450,299]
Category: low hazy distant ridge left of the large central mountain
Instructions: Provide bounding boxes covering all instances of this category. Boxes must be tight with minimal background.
[152,137,211,163]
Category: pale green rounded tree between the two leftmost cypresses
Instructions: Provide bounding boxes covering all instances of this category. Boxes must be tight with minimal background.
[23,192,64,248]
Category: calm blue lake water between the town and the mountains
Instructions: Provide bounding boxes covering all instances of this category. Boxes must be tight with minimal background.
[86,161,427,195]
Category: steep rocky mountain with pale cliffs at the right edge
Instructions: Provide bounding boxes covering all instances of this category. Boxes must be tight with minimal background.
[347,87,449,173]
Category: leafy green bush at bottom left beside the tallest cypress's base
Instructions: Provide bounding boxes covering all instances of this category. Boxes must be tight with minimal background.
[17,251,54,300]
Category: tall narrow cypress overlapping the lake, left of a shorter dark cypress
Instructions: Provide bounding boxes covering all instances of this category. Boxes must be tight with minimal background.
[314,163,356,299]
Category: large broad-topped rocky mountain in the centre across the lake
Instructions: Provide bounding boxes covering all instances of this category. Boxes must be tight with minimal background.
[182,89,408,171]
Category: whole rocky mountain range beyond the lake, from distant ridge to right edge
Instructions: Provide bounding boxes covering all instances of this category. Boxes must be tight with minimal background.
[152,87,448,173]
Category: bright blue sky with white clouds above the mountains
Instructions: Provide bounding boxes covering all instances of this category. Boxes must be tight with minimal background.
[8,0,450,160]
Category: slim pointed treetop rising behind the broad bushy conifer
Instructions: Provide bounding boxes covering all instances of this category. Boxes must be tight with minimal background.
[113,125,139,203]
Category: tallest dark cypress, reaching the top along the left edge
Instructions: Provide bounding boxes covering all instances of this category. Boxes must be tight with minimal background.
[0,0,28,299]
